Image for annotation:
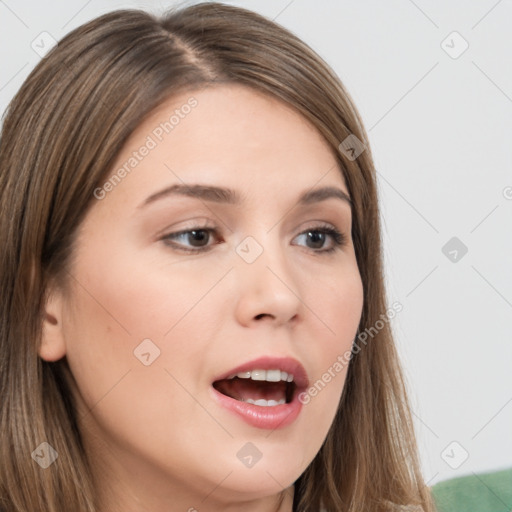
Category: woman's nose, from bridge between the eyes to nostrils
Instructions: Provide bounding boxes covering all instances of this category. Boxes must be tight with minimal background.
[233,235,303,326]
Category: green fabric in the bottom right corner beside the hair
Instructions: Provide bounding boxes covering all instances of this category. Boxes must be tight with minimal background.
[431,468,512,512]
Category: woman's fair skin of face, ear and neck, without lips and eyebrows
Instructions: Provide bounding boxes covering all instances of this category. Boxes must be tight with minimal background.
[39,85,363,512]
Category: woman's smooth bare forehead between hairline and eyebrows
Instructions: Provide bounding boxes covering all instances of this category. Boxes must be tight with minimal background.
[101,84,348,209]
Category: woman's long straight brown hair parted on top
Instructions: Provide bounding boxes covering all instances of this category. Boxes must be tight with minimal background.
[0,2,434,512]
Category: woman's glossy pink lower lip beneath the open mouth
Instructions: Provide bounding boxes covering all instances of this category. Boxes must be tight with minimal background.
[211,386,302,430]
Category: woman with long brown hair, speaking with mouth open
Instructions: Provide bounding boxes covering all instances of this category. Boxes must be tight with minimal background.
[0,2,434,512]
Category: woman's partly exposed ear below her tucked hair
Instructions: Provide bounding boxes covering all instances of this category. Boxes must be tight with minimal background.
[38,290,66,361]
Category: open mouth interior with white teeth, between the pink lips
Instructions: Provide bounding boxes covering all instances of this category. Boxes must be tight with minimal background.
[213,370,297,406]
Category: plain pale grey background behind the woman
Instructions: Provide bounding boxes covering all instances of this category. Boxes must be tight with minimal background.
[0,0,512,485]
